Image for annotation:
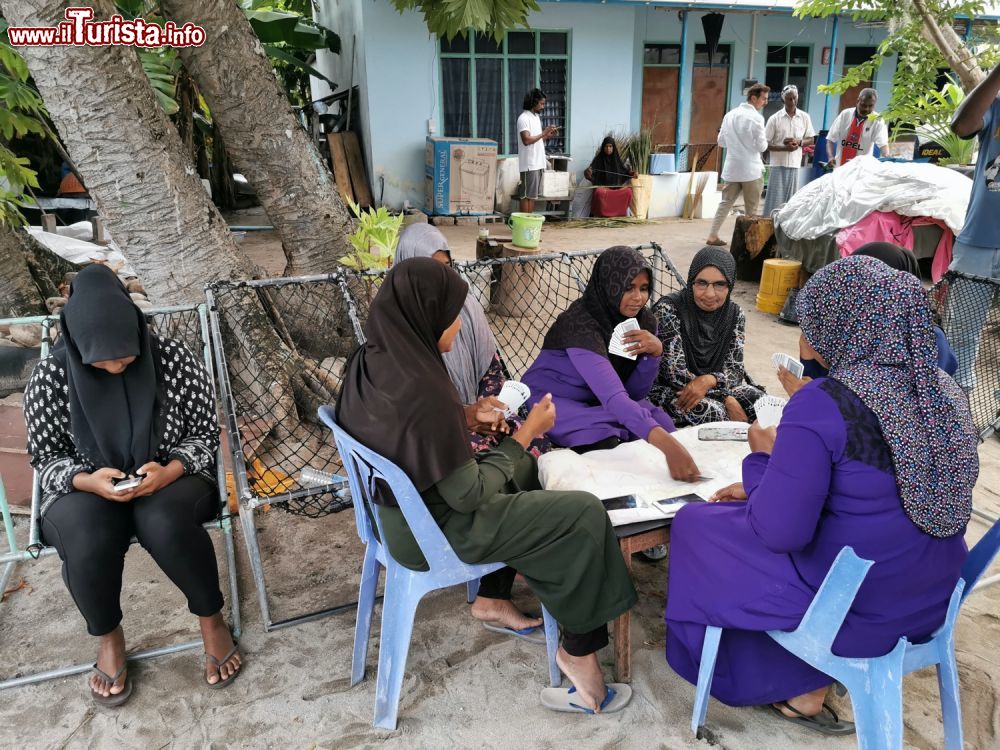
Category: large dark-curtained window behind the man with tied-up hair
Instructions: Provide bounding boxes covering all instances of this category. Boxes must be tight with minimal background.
[441,31,569,154]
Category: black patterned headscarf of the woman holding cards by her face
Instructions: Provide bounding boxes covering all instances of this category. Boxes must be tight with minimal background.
[542,245,656,382]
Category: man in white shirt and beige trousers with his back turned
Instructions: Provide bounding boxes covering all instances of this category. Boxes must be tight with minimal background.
[705,83,771,246]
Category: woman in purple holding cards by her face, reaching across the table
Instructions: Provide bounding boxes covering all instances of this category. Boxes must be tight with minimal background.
[523,245,698,481]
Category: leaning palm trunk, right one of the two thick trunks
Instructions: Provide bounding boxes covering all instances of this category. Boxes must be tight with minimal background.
[161,0,351,276]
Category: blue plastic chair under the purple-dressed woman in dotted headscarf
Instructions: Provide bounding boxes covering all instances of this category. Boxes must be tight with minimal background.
[691,521,1000,750]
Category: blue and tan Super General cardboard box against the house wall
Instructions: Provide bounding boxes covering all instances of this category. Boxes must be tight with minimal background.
[425,136,497,216]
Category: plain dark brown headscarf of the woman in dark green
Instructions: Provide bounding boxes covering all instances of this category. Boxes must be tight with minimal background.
[337,258,472,504]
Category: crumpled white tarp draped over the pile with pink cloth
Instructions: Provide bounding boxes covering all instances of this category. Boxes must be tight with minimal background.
[775,156,972,240]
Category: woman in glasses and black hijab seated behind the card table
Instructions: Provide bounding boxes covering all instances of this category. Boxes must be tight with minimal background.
[649,246,764,424]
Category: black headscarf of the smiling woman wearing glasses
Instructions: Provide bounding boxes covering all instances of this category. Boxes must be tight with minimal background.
[657,245,740,375]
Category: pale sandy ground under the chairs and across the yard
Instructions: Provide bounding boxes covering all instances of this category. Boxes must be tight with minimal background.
[0,212,1000,750]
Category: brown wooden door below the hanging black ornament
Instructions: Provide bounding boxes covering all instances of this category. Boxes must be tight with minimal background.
[688,44,731,171]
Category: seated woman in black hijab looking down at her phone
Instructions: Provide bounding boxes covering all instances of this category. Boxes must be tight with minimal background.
[24,265,240,706]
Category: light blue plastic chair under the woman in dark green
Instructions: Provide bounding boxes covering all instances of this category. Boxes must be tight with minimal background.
[319,406,562,729]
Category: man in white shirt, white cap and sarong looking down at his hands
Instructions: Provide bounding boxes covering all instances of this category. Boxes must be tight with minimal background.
[764,84,816,216]
